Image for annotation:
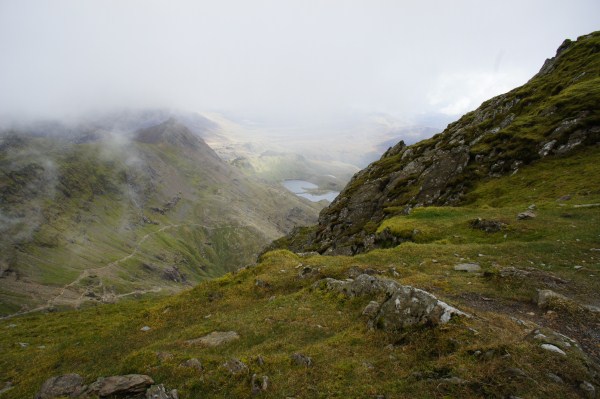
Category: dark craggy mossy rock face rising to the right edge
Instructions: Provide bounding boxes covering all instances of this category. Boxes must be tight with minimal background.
[282,32,600,255]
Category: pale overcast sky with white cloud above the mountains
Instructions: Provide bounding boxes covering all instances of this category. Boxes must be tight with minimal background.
[0,0,600,124]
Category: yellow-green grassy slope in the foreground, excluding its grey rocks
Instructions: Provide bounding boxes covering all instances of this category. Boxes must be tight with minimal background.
[0,147,600,398]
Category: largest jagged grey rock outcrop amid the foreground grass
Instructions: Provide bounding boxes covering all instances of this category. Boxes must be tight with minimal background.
[313,274,468,331]
